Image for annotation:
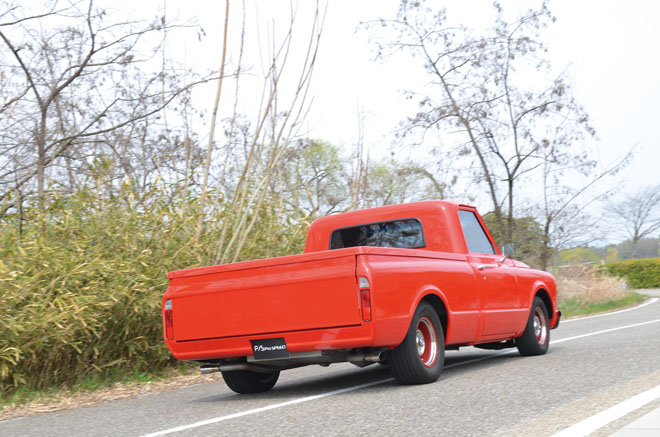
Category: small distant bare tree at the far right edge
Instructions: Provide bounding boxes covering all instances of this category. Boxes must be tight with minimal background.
[608,185,660,258]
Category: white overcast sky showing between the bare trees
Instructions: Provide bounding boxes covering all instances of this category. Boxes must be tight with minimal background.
[125,0,660,218]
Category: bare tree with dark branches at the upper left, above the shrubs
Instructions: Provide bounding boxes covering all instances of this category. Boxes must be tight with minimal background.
[0,0,206,218]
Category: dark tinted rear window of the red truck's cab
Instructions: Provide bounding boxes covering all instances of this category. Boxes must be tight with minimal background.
[330,218,426,250]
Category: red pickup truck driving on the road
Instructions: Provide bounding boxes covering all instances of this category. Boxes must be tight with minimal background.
[163,201,561,393]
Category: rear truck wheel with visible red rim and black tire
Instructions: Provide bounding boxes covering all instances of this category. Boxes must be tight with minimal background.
[387,302,445,384]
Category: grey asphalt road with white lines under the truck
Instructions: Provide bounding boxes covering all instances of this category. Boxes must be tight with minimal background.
[0,291,660,436]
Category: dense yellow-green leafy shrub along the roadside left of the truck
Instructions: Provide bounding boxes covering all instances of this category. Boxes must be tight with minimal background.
[0,190,305,394]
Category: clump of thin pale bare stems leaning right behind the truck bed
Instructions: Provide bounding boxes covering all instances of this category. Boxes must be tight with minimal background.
[214,3,323,263]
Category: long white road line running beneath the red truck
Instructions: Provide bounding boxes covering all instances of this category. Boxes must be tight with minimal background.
[142,319,660,437]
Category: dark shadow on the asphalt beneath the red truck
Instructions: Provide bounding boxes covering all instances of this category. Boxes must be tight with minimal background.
[193,351,523,403]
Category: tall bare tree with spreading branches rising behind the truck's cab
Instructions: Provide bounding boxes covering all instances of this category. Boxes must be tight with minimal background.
[372,0,594,241]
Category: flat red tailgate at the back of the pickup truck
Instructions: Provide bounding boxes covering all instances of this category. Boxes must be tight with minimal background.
[169,254,361,341]
